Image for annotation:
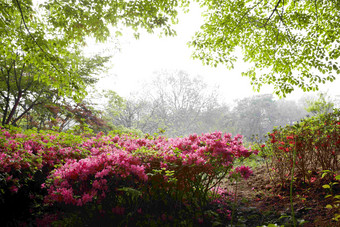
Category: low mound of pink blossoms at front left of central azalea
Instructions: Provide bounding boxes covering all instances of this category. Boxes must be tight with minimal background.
[45,147,148,206]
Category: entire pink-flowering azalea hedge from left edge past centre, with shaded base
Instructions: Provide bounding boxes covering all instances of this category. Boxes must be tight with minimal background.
[0,129,257,224]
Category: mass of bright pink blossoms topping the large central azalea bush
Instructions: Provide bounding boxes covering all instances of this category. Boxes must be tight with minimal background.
[41,132,252,205]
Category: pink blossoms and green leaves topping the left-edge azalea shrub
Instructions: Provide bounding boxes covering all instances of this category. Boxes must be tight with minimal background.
[0,129,89,192]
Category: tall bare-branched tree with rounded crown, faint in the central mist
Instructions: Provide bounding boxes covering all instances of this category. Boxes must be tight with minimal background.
[149,71,217,136]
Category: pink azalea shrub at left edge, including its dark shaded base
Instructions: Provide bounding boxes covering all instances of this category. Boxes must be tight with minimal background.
[0,128,93,225]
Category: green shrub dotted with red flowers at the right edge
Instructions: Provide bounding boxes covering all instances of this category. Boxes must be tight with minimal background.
[262,110,340,186]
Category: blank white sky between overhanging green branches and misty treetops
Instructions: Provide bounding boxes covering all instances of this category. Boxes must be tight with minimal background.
[94,4,340,103]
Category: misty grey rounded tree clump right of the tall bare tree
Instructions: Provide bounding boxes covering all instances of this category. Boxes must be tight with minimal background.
[225,94,307,141]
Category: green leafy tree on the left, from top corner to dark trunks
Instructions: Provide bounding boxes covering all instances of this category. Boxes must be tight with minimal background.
[0,0,108,127]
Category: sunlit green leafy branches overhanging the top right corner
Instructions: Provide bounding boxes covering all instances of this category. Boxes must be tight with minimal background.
[190,0,340,96]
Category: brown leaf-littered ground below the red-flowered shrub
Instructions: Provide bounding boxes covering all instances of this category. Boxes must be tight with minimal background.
[223,164,340,227]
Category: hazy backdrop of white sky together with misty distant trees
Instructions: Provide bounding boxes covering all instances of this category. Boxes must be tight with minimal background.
[79,4,340,141]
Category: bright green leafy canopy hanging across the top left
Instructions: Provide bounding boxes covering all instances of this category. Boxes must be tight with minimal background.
[0,0,186,101]
